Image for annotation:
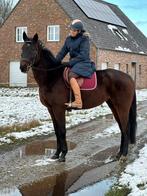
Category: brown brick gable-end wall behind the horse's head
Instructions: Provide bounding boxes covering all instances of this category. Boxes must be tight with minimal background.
[0,0,70,84]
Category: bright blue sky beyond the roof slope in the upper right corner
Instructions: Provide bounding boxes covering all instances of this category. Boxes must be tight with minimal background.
[11,0,147,37]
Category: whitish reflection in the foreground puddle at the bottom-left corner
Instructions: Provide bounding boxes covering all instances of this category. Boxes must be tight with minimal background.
[0,187,21,196]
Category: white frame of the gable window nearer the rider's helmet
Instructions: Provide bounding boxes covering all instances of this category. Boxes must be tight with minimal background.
[47,25,60,42]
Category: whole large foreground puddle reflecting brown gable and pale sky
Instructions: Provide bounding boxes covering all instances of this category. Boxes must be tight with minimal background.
[0,161,116,196]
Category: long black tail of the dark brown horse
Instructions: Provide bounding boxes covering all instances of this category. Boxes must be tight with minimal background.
[129,91,137,144]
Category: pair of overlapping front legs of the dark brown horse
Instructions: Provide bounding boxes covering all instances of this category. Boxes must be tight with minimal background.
[49,107,68,162]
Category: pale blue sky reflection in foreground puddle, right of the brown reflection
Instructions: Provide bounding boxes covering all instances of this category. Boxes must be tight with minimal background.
[68,177,116,196]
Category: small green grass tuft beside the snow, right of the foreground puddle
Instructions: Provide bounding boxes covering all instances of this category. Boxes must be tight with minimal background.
[105,186,131,196]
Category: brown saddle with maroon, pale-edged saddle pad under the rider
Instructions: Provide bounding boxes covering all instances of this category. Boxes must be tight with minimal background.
[63,67,97,91]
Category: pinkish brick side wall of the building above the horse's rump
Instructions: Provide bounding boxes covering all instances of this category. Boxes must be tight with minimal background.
[97,49,147,88]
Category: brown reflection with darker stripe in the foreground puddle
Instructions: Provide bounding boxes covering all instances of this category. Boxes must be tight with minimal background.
[19,166,84,196]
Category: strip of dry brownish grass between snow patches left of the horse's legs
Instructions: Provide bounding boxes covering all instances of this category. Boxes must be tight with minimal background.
[0,120,41,136]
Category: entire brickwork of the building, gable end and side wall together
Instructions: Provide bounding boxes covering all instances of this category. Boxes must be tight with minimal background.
[0,0,147,88]
